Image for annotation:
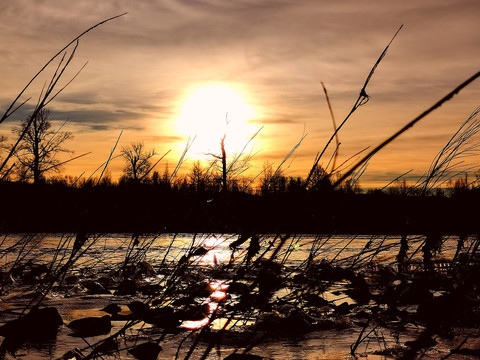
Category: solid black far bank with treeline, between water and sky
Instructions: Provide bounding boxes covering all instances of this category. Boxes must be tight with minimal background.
[0,170,480,234]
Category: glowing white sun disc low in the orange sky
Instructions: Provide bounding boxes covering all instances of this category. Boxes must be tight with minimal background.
[177,83,255,158]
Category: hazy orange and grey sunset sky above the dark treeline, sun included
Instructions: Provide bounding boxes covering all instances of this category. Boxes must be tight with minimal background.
[0,0,480,187]
